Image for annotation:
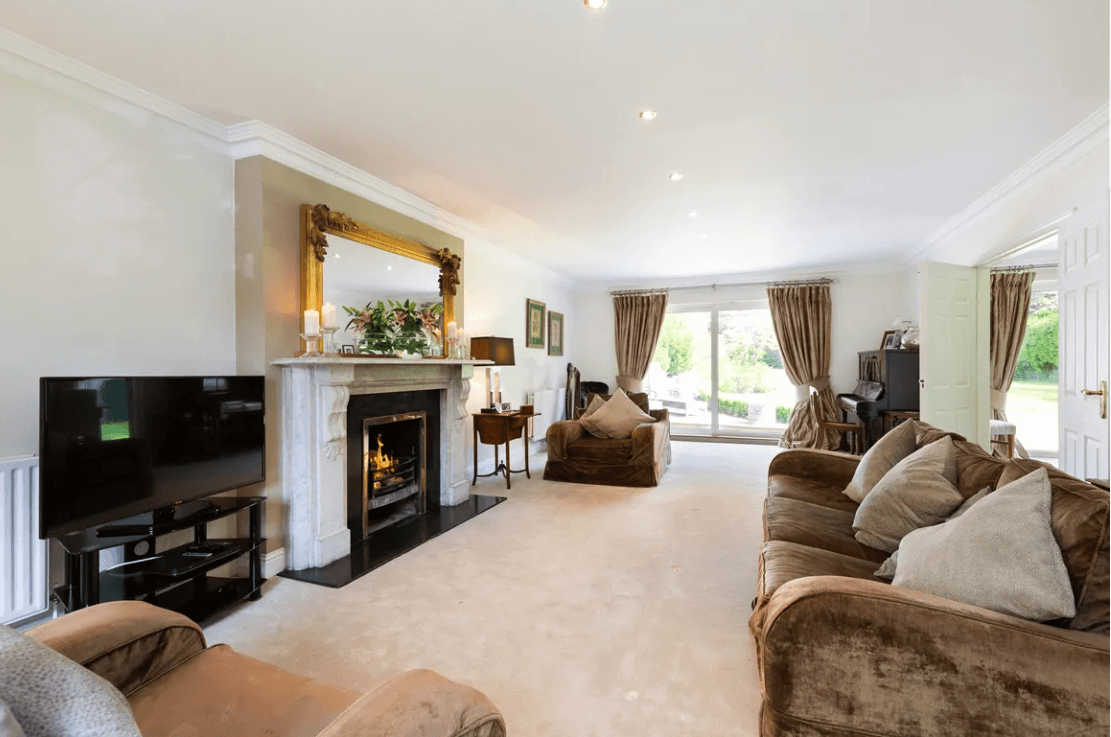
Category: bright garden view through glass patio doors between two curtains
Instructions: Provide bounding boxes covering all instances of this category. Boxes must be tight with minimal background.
[645,308,794,436]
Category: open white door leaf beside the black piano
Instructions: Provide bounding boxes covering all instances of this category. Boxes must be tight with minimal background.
[918,261,990,447]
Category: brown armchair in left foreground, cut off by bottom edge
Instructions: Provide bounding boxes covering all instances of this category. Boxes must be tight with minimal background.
[27,601,506,737]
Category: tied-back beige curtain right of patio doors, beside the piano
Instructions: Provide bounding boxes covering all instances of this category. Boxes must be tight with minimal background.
[768,285,841,450]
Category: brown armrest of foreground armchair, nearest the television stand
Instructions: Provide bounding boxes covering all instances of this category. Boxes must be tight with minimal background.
[27,601,206,695]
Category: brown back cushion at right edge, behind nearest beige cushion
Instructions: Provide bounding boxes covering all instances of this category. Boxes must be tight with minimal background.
[999,459,1111,635]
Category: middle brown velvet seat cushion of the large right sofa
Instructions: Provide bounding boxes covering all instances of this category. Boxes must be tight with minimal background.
[764,497,888,568]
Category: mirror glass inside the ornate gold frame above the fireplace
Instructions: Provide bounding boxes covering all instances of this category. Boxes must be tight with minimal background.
[323,233,443,346]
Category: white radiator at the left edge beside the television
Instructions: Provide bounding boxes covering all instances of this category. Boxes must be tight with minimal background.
[0,456,48,624]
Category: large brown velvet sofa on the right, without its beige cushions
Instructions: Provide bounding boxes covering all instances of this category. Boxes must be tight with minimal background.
[749,426,1111,737]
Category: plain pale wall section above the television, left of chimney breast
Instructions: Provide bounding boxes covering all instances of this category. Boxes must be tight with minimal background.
[0,66,236,457]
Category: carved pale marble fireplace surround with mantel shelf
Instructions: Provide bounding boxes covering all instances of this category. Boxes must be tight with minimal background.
[273,356,490,570]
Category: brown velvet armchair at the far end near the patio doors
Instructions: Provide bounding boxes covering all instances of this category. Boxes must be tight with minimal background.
[544,392,671,486]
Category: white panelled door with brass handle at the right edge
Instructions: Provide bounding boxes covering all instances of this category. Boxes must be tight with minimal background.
[1058,200,1109,478]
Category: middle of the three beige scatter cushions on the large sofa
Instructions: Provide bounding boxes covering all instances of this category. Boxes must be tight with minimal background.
[852,438,964,552]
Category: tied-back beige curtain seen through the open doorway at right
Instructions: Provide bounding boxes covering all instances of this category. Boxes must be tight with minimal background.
[991,271,1034,458]
